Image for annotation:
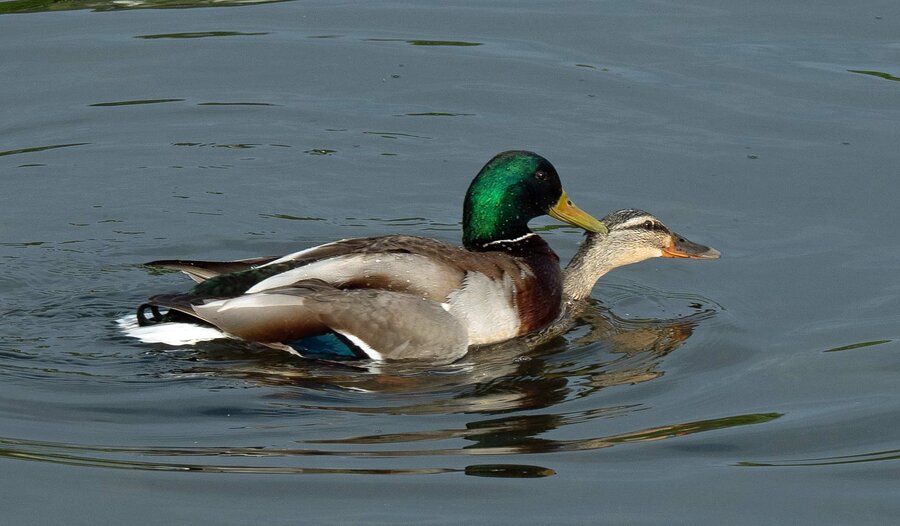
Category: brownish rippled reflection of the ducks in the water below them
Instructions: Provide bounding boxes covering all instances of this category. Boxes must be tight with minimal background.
[165,300,720,455]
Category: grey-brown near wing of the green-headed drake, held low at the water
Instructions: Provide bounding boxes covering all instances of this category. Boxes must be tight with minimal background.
[159,280,468,361]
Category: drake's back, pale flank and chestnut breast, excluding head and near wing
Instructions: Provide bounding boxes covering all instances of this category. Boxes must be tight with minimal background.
[156,234,561,345]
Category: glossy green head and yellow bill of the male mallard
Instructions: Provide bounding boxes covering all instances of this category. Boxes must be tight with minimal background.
[463,151,606,249]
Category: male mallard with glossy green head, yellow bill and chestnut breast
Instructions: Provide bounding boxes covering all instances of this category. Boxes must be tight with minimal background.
[138,151,606,361]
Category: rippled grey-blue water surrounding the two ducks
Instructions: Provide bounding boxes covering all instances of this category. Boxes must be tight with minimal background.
[0,0,900,525]
